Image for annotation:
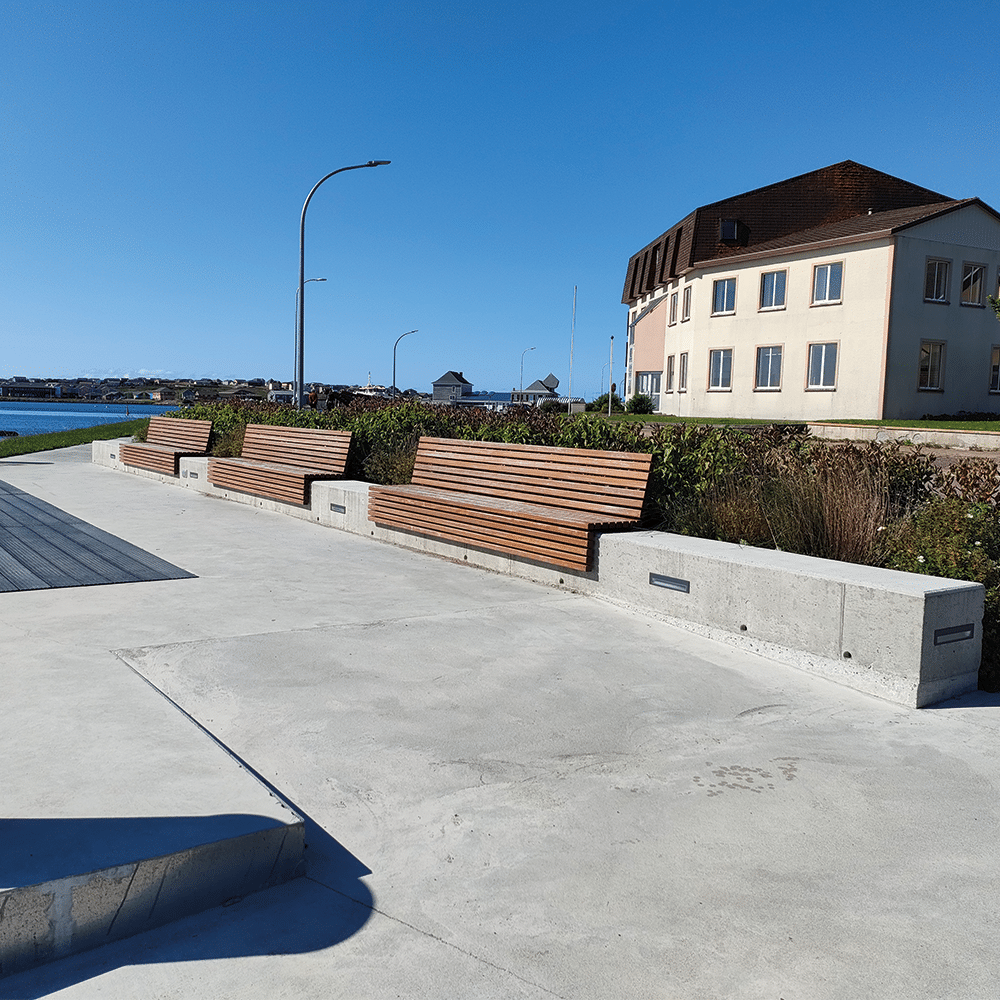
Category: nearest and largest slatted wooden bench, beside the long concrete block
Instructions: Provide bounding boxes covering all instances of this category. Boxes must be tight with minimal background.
[368,437,652,570]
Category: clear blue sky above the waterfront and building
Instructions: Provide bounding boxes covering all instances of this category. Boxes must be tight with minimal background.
[0,0,1000,398]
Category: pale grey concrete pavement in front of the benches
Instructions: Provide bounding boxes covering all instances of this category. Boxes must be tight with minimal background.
[0,446,1000,1000]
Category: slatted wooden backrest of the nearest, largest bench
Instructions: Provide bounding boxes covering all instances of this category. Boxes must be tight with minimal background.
[411,437,652,520]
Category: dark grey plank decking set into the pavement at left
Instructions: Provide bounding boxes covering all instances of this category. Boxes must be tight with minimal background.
[0,480,194,593]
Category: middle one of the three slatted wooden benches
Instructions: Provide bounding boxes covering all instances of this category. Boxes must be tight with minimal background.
[208,424,351,506]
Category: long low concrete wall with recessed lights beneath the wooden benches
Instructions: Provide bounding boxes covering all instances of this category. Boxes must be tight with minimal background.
[94,442,984,707]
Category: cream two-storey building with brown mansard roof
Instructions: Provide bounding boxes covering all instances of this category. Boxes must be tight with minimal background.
[622,160,1000,420]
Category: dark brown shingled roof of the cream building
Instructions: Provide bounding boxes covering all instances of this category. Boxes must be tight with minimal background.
[622,160,958,304]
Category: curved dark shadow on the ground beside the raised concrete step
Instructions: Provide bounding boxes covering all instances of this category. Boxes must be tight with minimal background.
[0,810,374,1000]
